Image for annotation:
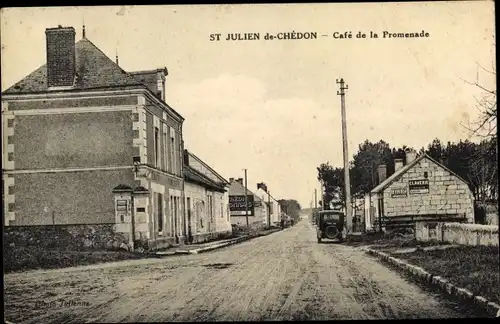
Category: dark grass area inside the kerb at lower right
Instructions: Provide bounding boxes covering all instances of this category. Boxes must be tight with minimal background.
[397,246,500,304]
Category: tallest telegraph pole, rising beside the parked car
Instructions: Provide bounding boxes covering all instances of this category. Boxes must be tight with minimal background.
[337,79,352,233]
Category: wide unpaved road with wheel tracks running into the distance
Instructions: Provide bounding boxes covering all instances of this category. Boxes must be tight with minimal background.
[4,220,478,324]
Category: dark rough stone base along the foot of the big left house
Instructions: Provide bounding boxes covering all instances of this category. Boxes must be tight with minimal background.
[3,224,128,251]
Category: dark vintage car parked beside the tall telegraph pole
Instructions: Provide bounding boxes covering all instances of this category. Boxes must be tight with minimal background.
[316,210,345,243]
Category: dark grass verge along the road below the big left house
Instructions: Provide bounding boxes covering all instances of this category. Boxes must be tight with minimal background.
[4,246,152,273]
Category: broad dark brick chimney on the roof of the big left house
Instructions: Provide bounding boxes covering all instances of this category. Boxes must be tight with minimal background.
[45,25,76,88]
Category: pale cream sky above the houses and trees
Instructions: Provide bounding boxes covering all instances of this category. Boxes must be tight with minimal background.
[1,1,496,207]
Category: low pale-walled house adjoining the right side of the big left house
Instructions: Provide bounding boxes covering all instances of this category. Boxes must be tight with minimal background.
[184,150,232,243]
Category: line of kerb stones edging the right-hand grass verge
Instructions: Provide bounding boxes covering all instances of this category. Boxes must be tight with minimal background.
[364,248,500,317]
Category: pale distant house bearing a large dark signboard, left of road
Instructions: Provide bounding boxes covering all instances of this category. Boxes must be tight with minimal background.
[229,178,267,225]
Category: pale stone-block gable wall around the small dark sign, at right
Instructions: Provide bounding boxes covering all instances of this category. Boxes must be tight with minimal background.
[380,158,474,223]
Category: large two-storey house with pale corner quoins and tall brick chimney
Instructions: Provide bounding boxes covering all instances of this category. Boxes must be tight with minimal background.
[2,26,184,251]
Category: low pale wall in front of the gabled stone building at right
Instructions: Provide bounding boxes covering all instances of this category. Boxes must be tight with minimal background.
[415,223,498,246]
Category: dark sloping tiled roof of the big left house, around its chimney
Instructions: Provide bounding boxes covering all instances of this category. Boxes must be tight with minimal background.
[4,38,145,94]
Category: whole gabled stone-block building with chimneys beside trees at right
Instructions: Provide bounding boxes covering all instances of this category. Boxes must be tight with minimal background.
[365,152,474,229]
